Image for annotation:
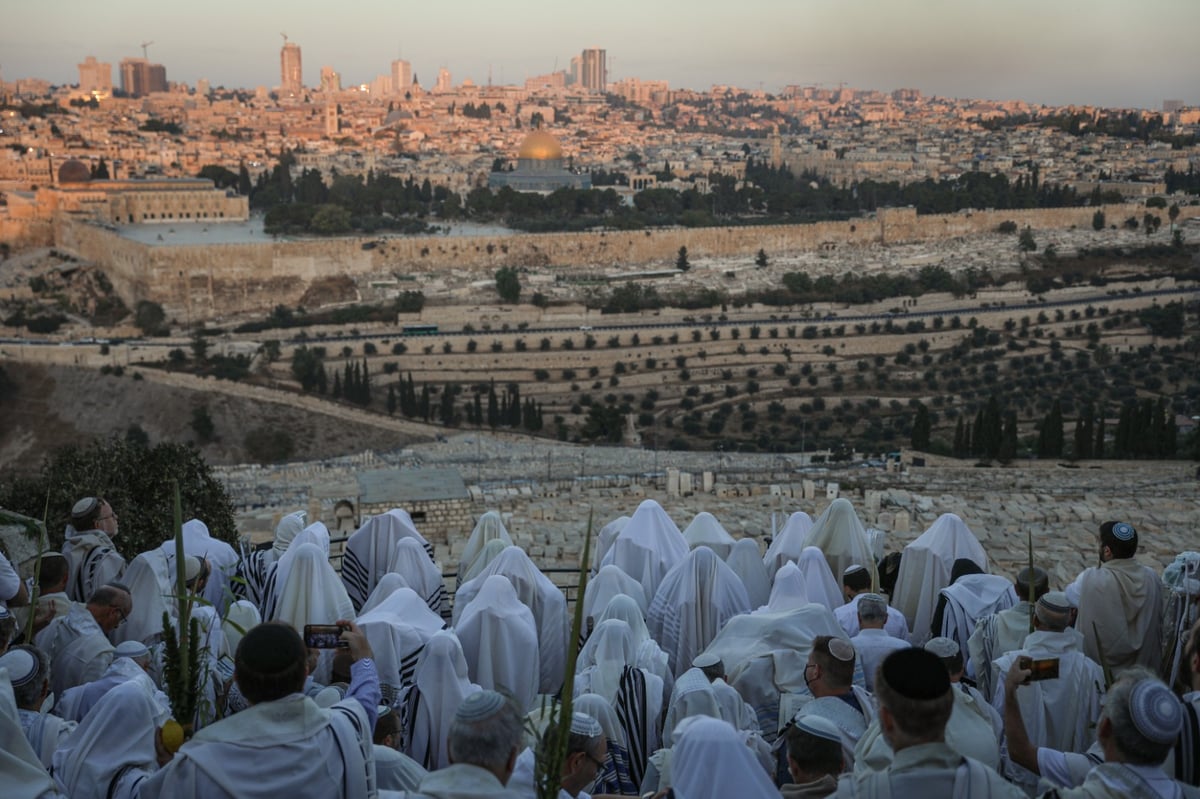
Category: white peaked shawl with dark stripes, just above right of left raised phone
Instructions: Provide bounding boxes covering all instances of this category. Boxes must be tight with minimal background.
[360,588,445,704]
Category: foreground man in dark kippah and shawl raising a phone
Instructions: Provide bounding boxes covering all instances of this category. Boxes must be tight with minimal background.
[139,620,379,799]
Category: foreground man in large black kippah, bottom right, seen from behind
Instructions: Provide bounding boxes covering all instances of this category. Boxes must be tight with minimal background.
[835,648,1025,799]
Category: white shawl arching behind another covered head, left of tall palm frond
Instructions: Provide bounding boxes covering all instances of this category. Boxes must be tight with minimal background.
[455,547,569,693]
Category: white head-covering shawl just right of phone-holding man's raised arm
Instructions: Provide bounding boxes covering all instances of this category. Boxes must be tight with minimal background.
[403,630,480,770]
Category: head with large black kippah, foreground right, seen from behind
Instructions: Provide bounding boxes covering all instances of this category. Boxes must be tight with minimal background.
[875,647,954,752]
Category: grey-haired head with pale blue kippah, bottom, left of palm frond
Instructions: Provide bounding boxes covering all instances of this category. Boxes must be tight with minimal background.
[446,690,524,785]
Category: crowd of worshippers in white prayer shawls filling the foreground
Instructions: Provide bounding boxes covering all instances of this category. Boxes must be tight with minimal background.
[0,497,1200,799]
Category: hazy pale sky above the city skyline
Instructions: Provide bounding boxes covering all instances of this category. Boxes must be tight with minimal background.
[0,0,1200,108]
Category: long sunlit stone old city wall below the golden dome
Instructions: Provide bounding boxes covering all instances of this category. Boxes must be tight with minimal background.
[55,204,1200,322]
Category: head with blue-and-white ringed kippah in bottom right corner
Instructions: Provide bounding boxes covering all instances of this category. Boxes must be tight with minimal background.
[1096,667,1183,765]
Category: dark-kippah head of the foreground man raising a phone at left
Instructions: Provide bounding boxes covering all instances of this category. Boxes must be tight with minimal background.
[233,621,308,704]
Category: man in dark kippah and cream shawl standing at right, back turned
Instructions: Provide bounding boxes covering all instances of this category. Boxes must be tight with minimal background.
[1067,522,1163,673]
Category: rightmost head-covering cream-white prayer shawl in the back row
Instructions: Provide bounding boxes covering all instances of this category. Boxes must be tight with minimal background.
[892,513,988,647]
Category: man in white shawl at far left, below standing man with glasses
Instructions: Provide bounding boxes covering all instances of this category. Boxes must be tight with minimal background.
[35,585,133,696]
